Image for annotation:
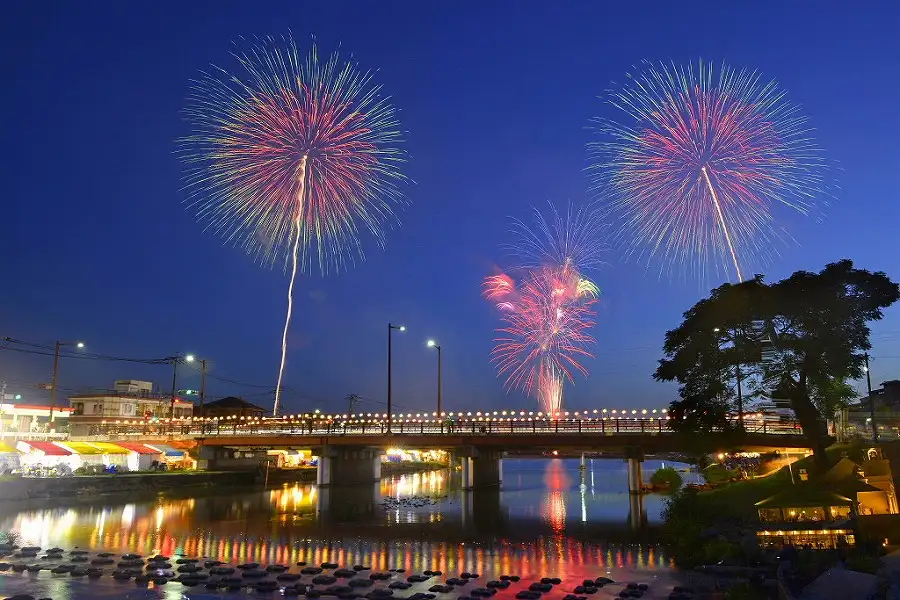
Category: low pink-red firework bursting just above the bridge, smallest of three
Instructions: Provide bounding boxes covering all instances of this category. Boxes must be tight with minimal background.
[482,206,602,413]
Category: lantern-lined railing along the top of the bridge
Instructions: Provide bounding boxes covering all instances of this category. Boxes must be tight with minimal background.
[82,417,803,439]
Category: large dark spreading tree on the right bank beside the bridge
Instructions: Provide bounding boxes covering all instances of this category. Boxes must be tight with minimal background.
[654,260,900,466]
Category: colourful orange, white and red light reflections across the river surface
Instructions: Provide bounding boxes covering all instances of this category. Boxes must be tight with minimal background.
[0,460,680,579]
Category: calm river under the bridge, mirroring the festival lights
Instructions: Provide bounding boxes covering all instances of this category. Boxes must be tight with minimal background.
[0,459,695,600]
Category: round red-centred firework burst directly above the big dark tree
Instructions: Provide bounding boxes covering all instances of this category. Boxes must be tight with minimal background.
[589,62,829,281]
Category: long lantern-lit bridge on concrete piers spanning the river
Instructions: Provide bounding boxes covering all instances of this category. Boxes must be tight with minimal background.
[72,409,809,491]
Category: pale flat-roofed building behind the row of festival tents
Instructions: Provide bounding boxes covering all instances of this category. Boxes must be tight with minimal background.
[69,379,194,436]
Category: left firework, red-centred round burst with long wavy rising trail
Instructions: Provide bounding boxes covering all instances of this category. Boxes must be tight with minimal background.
[179,37,405,414]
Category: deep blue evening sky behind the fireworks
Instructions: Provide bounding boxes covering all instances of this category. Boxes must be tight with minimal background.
[0,0,900,410]
